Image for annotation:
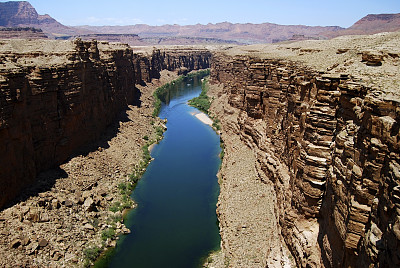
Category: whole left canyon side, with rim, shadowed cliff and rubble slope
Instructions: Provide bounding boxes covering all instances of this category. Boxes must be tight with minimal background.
[0,40,211,267]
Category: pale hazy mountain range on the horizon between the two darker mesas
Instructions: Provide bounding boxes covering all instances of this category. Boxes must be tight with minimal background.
[75,22,343,44]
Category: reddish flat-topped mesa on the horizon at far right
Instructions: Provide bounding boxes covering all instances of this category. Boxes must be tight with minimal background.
[326,13,400,37]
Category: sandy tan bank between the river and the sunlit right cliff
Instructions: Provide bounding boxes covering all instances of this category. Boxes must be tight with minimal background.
[204,85,292,268]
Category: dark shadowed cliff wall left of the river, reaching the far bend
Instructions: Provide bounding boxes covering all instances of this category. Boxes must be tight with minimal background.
[0,40,210,207]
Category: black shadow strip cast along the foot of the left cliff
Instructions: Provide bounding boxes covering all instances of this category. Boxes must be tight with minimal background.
[0,96,141,211]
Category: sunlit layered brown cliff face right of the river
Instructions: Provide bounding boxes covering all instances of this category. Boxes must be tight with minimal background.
[211,37,400,267]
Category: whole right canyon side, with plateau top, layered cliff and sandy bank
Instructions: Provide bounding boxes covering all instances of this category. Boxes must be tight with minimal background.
[210,33,400,267]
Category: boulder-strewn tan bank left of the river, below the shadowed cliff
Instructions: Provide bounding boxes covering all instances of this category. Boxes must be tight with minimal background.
[0,71,178,267]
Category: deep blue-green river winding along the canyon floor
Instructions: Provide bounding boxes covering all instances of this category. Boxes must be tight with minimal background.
[103,75,220,268]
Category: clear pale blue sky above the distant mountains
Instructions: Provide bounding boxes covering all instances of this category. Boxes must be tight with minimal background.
[1,0,400,27]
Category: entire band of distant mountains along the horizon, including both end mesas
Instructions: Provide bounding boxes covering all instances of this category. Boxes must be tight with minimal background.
[0,1,400,45]
